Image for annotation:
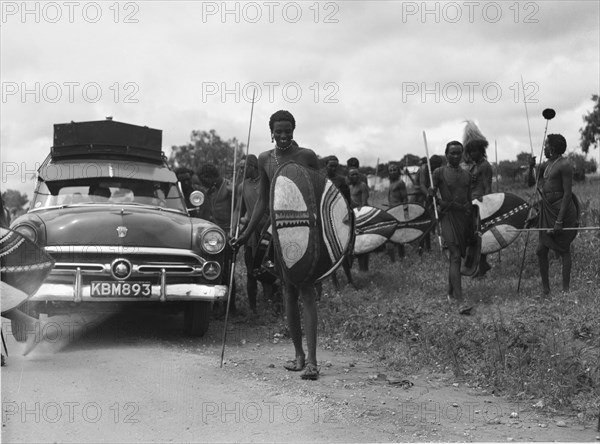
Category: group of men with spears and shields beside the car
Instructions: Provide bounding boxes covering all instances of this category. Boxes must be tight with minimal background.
[2,110,578,380]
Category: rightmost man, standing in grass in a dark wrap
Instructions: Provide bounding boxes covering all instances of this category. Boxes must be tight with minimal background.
[530,134,579,295]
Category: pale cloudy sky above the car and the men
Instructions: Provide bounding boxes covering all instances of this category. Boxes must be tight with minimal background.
[0,1,600,196]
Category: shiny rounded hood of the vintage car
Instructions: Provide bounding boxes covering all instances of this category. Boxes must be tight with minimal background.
[35,205,193,249]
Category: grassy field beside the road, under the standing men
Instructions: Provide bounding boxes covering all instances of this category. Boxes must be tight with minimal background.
[238,182,600,420]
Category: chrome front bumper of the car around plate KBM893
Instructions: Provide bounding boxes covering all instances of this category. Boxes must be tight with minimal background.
[29,282,227,302]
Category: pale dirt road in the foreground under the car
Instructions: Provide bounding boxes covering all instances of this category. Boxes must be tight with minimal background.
[2,314,600,443]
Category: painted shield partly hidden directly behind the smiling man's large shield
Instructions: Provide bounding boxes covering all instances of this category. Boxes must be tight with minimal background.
[354,205,398,254]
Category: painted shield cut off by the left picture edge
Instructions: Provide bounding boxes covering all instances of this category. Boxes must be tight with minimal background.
[0,227,54,311]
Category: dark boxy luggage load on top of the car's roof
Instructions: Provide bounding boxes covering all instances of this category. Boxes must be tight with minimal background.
[50,119,164,163]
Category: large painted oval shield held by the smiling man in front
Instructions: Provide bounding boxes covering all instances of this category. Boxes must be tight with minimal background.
[270,162,354,285]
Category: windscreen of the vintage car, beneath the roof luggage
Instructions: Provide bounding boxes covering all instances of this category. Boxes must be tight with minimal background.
[32,177,187,212]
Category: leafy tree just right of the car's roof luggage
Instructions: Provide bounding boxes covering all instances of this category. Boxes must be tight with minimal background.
[168,129,245,178]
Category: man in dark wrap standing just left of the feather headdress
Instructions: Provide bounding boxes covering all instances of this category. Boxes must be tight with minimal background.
[431,140,473,302]
